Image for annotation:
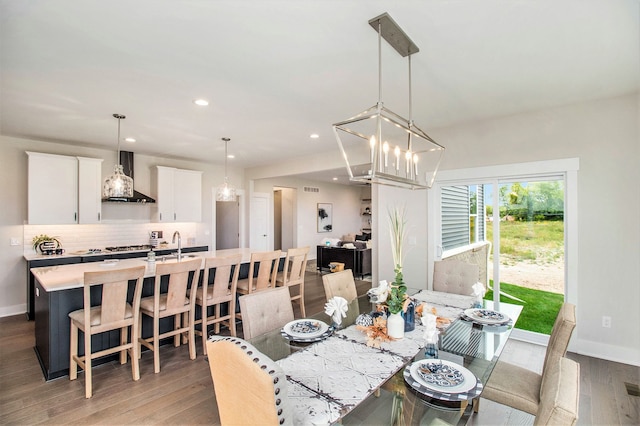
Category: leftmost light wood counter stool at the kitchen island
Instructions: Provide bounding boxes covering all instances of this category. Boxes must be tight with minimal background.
[69,266,145,398]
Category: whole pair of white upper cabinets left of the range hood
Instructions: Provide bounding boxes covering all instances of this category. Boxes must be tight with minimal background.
[27,152,102,225]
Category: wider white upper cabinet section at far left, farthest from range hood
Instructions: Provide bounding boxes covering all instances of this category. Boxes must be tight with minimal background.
[27,152,78,225]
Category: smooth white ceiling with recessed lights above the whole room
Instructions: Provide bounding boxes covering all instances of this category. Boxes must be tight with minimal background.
[0,0,640,176]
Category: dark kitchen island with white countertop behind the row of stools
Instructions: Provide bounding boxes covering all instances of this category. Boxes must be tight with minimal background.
[31,249,285,380]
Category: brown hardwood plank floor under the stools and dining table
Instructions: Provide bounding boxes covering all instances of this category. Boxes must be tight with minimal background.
[0,272,640,426]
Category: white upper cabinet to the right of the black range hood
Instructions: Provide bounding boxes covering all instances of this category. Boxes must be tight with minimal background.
[151,166,202,222]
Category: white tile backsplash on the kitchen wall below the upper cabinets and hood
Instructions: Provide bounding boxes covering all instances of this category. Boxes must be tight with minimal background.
[24,223,198,254]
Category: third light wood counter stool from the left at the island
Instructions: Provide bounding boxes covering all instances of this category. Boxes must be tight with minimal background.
[194,254,242,355]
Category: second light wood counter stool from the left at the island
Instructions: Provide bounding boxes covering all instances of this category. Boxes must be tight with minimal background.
[138,257,202,373]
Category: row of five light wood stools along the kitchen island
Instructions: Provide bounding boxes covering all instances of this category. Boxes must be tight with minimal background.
[69,248,308,398]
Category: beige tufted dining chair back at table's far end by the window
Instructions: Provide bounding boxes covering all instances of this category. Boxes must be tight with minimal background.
[433,259,480,296]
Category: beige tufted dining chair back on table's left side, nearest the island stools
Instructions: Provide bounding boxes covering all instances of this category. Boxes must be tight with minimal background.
[238,287,294,339]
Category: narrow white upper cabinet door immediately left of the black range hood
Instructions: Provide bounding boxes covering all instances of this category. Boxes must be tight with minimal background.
[78,157,102,223]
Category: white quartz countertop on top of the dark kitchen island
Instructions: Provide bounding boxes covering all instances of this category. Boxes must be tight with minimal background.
[31,248,251,292]
